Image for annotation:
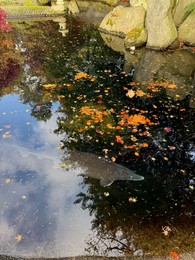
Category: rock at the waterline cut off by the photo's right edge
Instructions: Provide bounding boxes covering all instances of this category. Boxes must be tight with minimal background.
[178,10,195,46]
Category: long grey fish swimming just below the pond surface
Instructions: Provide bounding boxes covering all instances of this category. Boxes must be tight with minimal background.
[1,144,144,186]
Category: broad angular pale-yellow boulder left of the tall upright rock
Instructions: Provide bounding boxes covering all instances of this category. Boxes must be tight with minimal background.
[99,6,146,42]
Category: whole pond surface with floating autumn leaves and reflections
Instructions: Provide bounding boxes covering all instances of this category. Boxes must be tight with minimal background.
[0,17,195,258]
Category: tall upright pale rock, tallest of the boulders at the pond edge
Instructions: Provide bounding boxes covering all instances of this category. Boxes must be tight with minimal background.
[146,0,177,50]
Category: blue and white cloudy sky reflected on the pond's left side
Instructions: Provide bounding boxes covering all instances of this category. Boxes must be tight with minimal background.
[0,96,91,257]
